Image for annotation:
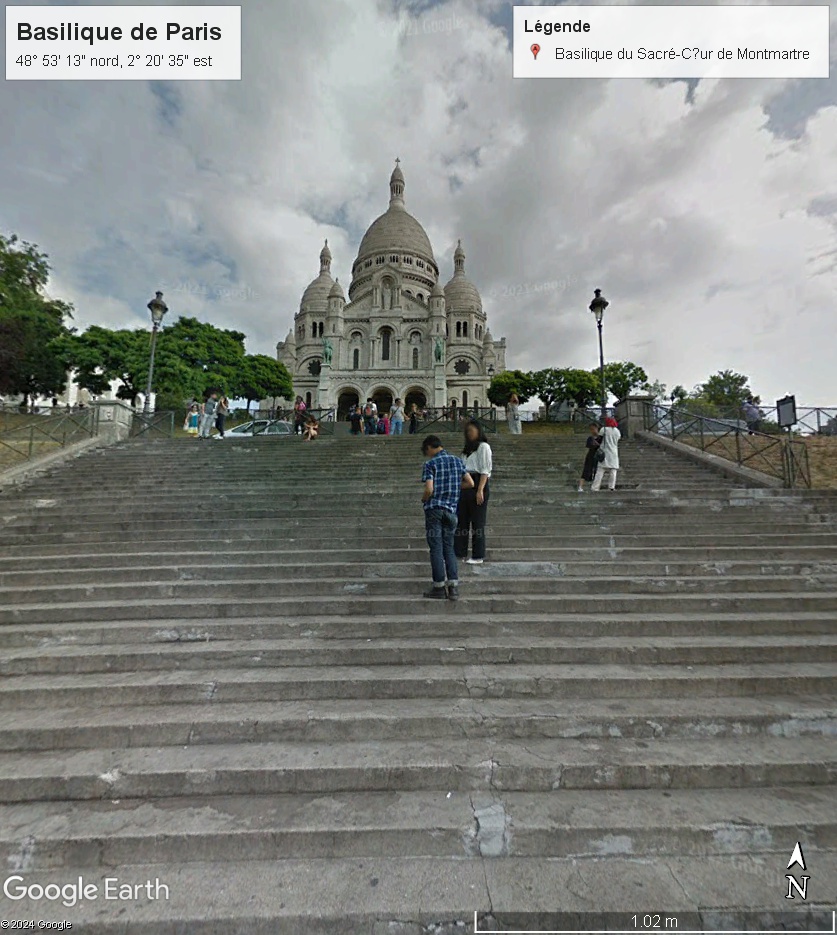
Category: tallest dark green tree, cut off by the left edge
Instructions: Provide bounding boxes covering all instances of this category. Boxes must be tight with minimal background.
[0,234,72,403]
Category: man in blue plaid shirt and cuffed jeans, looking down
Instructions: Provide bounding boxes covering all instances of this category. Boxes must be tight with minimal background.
[421,435,474,601]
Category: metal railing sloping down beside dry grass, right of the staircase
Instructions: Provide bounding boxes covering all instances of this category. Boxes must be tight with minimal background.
[643,403,811,487]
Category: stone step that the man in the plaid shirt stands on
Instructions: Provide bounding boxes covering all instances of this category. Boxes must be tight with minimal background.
[0,596,837,630]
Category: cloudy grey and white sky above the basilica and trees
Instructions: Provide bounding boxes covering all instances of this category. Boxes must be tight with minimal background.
[0,0,837,405]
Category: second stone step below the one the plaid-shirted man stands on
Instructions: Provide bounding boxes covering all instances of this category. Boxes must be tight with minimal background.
[0,627,837,676]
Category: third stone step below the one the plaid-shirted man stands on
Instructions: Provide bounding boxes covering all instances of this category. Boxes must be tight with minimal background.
[0,661,837,712]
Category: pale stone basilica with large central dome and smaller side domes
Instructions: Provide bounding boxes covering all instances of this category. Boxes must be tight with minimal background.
[276,160,506,417]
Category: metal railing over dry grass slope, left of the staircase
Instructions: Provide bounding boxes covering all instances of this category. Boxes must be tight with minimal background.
[0,407,99,468]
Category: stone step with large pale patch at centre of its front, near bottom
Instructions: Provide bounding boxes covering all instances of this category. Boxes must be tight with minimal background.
[0,786,837,875]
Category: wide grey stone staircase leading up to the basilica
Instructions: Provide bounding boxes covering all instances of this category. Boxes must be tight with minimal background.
[0,435,837,935]
